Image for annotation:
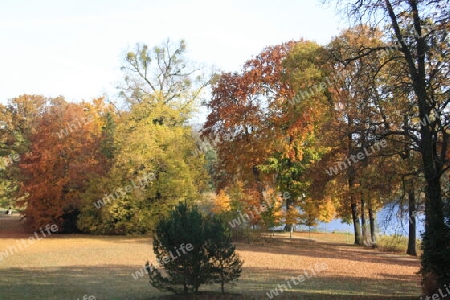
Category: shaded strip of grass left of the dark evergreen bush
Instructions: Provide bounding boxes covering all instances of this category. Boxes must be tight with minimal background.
[0,265,158,300]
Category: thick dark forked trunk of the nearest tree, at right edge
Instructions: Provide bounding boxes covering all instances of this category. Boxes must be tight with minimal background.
[384,0,450,288]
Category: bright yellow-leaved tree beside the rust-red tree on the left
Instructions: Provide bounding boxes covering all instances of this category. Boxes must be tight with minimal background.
[79,102,206,233]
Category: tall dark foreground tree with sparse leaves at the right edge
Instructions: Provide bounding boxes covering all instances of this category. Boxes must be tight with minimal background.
[326,0,450,294]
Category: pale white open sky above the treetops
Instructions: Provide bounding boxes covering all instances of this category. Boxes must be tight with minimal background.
[0,0,346,120]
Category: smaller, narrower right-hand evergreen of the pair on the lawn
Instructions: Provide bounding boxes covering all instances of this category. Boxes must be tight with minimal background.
[206,216,244,293]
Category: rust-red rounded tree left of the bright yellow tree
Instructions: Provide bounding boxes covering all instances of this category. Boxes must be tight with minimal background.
[18,98,107,232]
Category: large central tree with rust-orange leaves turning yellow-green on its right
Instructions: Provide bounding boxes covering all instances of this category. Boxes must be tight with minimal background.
[203,41,324,230]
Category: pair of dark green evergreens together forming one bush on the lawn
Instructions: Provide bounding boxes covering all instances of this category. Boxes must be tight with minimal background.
[146,203,242,294]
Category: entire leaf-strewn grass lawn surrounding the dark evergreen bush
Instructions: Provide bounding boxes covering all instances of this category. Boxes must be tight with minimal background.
[0,215,420,300]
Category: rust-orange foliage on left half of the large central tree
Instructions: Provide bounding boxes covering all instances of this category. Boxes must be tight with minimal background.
[203,42,308,189]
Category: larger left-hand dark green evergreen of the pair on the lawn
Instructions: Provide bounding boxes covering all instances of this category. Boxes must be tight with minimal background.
[147,203,210,294]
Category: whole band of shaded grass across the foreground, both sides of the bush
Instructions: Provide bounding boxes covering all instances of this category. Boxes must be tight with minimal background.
[0,265,420,300]
